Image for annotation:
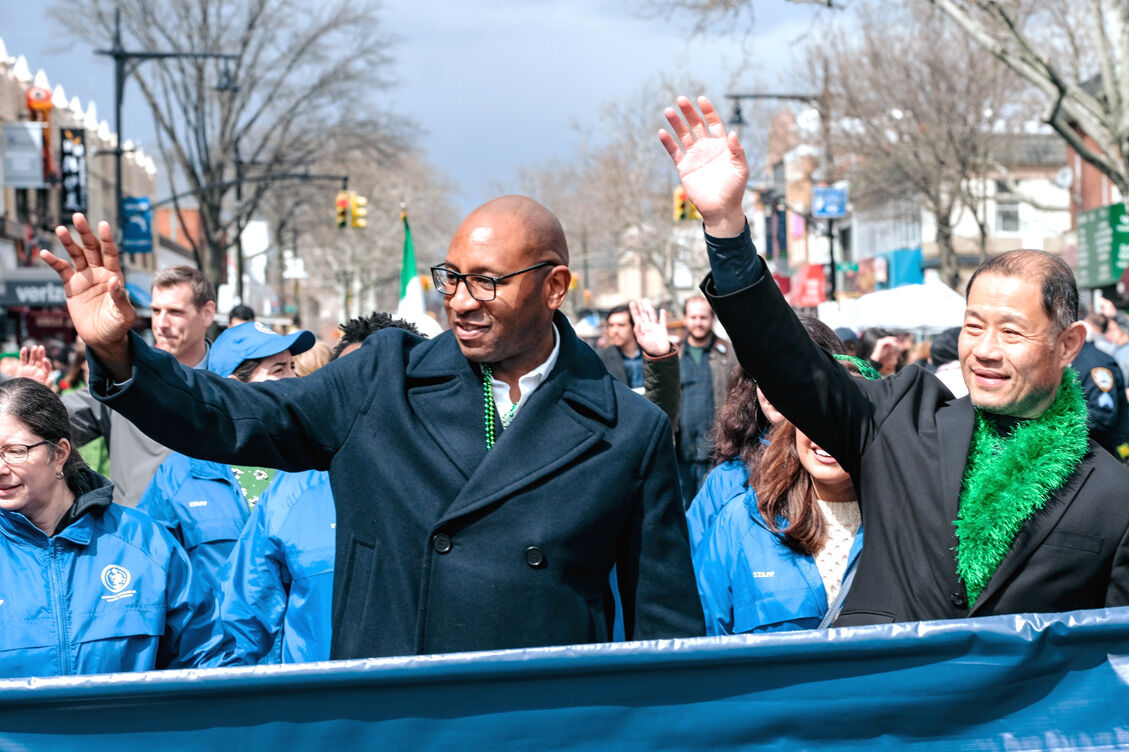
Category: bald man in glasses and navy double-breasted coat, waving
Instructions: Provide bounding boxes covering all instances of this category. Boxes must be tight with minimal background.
[43,196,703,658]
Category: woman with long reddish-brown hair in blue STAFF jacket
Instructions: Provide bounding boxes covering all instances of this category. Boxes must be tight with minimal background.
[693,355,877,635]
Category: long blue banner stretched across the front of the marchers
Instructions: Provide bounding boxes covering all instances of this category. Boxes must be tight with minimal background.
[0,609,1129,752]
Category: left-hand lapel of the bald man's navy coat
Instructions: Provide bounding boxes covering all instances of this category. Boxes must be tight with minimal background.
[405,332,487,478]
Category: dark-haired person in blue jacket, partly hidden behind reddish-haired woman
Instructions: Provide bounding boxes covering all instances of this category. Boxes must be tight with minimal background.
[686,314,846,553]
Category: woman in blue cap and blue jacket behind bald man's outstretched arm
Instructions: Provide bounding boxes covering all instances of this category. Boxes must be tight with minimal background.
[138,322,315,594]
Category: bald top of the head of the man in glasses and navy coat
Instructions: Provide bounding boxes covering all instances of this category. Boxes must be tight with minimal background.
[455,195,568,266]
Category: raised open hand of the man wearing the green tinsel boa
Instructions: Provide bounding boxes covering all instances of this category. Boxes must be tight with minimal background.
[658,97,749,237]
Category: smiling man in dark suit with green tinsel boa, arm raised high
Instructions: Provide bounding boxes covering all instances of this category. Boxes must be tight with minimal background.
[659,98,1129,626]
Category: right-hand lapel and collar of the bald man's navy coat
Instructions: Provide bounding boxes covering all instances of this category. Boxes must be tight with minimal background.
[438,314,616,524]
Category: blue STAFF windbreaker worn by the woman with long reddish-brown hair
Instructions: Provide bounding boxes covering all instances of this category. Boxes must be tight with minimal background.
[693,488,863,635]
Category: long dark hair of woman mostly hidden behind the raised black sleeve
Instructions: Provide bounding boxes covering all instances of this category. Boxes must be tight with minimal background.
[711,314,846,474]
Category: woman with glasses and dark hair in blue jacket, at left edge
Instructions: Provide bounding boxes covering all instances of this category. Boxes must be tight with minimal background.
[0,378,235,679]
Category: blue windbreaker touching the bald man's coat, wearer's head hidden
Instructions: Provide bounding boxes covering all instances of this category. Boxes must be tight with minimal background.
[220,470,336,663]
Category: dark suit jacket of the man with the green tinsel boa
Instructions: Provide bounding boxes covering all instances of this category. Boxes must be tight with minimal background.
[702,267,1129,626]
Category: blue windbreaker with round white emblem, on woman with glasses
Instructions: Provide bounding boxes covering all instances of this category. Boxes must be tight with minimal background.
[0,471,235,679]
